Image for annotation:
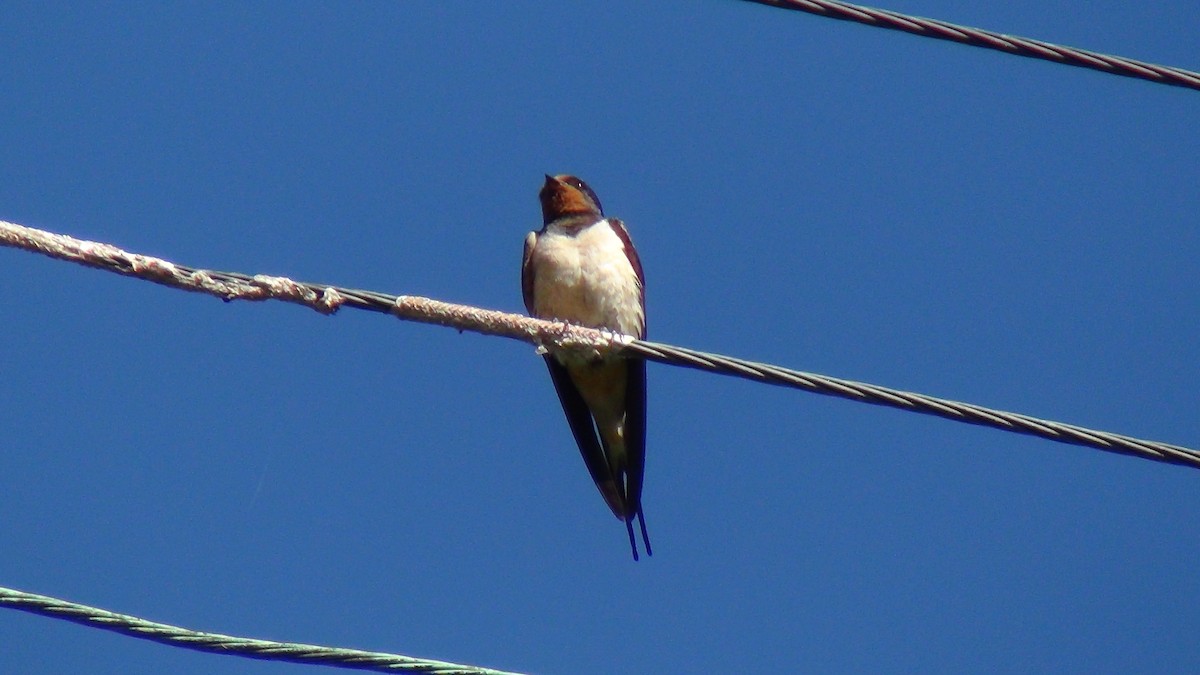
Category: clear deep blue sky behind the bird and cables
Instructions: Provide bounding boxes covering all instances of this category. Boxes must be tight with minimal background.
[0,0,1200,675]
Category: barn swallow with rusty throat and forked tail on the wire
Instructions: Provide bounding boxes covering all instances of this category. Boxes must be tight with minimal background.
[521,175,654,560]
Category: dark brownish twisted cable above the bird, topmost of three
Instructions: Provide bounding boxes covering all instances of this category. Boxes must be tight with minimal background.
[749,0,1200,90]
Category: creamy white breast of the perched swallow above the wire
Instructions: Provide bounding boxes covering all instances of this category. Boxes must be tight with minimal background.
[532,220,646,336]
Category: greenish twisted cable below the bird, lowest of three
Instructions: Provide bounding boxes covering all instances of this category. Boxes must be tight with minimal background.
[0,587,518,675]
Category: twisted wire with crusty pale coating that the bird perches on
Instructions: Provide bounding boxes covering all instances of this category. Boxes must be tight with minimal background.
[0,221,1200,468]
